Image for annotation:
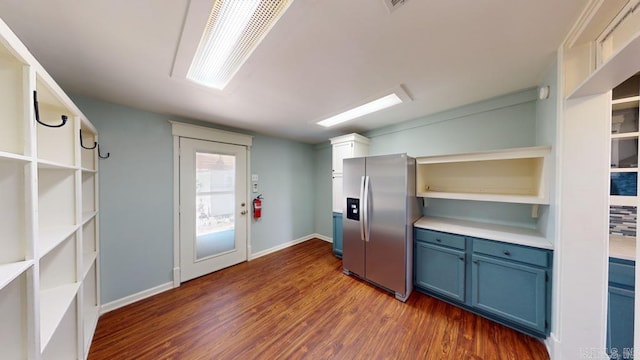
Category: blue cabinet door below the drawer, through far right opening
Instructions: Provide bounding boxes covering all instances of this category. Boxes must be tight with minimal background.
[607,286,635,359]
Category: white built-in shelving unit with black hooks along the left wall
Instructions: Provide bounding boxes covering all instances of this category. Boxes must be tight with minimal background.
[0,15,100,359]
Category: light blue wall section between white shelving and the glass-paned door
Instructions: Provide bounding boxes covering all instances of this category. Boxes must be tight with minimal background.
[73,97,173,303]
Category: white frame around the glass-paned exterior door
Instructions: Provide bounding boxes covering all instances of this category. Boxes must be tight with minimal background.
[169,121,253,288]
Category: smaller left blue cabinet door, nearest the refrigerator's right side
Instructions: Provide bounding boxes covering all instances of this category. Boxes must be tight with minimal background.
[415,241,465,302]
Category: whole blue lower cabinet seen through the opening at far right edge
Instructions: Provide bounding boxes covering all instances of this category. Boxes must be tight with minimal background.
[607,258,635,359]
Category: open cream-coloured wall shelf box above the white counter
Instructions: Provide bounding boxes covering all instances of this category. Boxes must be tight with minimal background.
[416,146,551,204]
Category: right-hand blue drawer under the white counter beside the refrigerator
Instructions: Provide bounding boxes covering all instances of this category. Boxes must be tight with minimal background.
[473,239,549,268]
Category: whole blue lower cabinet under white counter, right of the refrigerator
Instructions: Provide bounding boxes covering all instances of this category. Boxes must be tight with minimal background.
[414,228,553,338]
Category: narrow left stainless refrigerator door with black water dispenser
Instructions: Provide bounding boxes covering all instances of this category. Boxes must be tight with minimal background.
[342,158,365,277]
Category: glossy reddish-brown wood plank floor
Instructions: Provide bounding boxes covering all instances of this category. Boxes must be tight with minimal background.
[89,239,549,360]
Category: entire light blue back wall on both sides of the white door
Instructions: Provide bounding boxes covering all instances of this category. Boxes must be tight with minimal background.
[73,96,318,303]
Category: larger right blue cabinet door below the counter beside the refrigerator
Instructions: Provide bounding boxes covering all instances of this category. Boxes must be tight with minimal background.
[471,254,547,333]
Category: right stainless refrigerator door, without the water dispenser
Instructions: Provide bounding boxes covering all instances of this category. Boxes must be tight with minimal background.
[363,154,408,295]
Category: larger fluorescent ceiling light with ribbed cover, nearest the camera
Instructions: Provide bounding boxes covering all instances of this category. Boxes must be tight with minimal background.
[187,0,293,90]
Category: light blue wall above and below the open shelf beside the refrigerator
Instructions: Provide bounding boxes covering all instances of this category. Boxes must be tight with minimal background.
[363,89,537,228]
